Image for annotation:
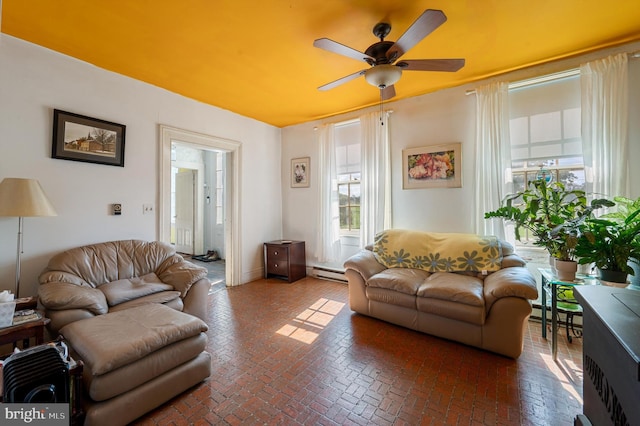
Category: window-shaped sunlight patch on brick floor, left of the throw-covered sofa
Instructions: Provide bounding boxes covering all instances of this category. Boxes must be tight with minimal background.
[276,298,345,344]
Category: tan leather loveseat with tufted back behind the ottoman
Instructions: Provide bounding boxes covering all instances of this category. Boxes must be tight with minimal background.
[38,240,210,335]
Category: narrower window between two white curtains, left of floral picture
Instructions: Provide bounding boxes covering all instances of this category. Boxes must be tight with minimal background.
[334,120,360,234]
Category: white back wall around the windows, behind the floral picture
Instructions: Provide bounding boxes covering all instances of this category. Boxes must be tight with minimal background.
[282,43,640,263]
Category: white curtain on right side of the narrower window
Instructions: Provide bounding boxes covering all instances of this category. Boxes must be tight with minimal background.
[360,112,391,247]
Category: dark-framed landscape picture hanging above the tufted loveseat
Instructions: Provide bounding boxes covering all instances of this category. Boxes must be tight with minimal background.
[51,109,126,167]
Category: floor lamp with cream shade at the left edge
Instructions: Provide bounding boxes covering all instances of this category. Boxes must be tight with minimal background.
[0,178,57,298]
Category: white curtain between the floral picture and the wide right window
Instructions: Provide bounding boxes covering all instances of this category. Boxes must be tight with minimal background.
[474,83,512,239]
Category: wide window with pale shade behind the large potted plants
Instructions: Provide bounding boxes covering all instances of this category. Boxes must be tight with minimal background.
[509,73,585,242]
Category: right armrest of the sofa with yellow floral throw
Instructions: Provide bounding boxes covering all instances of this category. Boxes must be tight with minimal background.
[484,266,538,312]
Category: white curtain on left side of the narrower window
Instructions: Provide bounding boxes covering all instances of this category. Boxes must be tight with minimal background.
[316,124,340,263]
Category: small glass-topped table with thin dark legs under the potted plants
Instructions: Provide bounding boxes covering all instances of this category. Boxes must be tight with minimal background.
[538,268,600,361]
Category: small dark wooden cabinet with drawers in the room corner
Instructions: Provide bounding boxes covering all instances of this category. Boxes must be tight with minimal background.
[264,240,307,283]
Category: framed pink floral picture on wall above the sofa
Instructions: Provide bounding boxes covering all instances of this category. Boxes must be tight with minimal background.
[402,142,462,189]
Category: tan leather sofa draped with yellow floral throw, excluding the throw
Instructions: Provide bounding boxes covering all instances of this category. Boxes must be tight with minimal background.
[344,231,538,358]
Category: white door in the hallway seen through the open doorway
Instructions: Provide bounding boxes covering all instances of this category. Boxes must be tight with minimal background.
[175,170,197,254]
